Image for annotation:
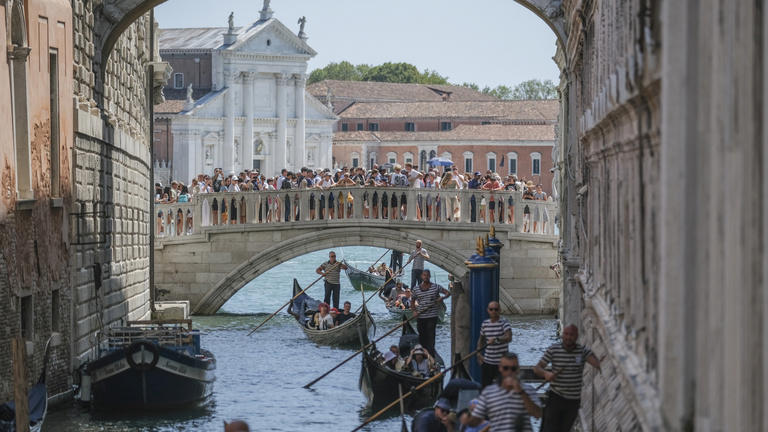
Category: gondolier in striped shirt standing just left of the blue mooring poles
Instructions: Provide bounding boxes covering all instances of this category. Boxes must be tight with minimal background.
[411,270,451,357]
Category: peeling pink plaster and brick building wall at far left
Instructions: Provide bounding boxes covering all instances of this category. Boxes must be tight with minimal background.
[0,0,72,401]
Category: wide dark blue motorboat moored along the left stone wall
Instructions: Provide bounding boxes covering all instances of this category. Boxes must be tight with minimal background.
[80,320,216,411]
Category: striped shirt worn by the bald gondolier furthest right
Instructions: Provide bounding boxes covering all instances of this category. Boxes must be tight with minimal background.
[539,343,592,399]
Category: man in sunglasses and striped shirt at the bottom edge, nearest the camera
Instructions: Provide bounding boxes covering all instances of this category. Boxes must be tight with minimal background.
[469,352,541,432]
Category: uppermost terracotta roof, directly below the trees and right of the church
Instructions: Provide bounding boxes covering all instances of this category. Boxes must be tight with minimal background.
[307,80,498,112]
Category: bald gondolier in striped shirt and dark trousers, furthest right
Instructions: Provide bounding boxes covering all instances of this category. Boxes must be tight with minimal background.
[533,324,600,432]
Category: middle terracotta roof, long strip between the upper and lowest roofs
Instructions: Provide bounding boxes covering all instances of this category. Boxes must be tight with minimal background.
[339,100,560,123]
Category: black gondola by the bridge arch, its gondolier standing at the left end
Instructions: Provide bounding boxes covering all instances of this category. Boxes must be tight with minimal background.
[288,279,375,346]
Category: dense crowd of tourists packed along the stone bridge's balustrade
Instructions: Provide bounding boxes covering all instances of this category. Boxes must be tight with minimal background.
[155,164,551,234]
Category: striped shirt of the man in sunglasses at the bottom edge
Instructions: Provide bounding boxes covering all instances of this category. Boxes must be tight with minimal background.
[472,384,541,432]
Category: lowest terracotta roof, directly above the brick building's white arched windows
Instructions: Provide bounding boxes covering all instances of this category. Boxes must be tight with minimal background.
[333,124,555,142]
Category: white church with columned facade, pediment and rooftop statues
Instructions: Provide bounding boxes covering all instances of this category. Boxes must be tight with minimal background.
[154,9,336,183]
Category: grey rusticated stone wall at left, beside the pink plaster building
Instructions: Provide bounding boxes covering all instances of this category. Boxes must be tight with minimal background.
[71,0,152,363]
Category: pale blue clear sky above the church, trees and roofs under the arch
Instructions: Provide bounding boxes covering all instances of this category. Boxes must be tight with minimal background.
[155,0,559,88]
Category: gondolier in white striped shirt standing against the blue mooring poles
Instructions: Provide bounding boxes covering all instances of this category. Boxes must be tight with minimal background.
[477,301,512,387]
